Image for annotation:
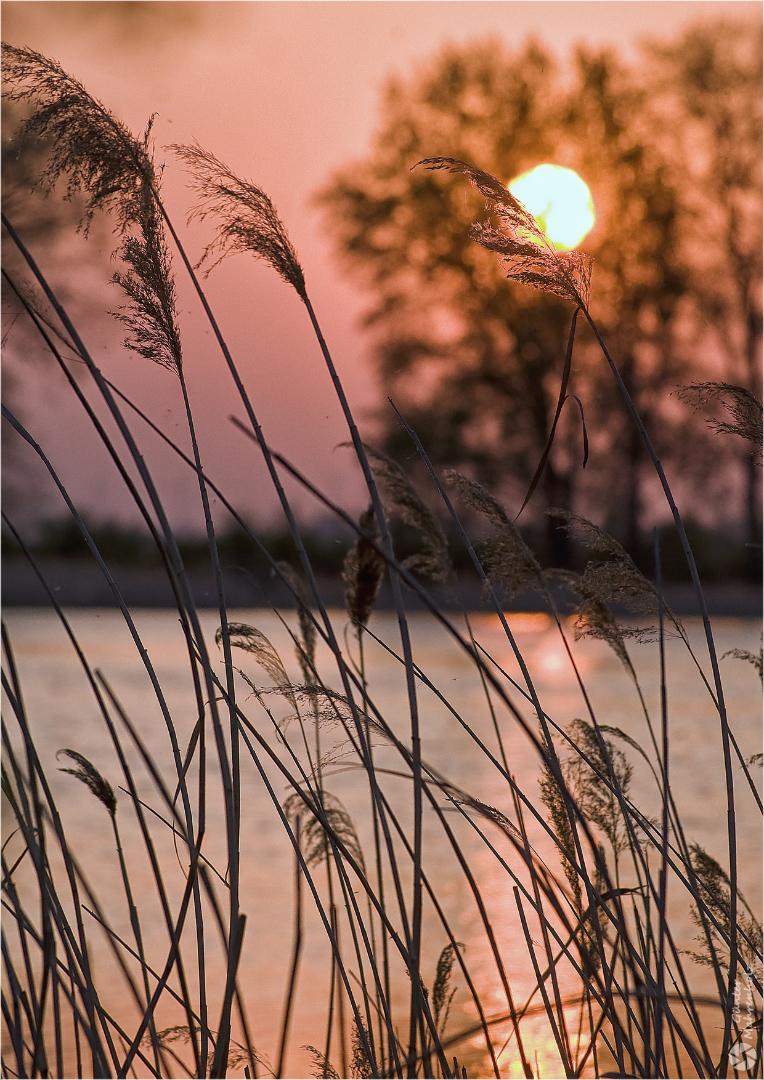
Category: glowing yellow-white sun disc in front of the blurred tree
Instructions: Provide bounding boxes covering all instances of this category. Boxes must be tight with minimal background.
[509,164,594,251]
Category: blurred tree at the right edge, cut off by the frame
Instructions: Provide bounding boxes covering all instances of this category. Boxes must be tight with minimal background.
[653,22,762,562]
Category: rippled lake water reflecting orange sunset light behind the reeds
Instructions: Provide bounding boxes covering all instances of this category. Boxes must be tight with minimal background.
[4,609,761,1077]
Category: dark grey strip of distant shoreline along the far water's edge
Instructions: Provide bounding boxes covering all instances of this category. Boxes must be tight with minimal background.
[2,556,763,618]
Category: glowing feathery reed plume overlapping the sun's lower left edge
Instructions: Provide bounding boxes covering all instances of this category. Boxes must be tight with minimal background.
[414,158,593,309]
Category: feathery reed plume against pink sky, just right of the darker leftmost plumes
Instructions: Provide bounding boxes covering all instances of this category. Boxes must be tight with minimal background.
[169,145,306,299]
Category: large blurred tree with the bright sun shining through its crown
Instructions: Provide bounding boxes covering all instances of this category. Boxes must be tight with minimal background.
[321,25,760,559]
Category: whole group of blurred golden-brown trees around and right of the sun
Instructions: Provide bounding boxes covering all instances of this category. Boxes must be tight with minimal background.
[320,24,761,564]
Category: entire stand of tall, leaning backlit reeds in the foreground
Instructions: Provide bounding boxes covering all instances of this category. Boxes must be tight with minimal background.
[2,46,762,1078]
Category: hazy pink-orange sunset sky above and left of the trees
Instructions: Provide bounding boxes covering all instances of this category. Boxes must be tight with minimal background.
[2,0,761,529]
